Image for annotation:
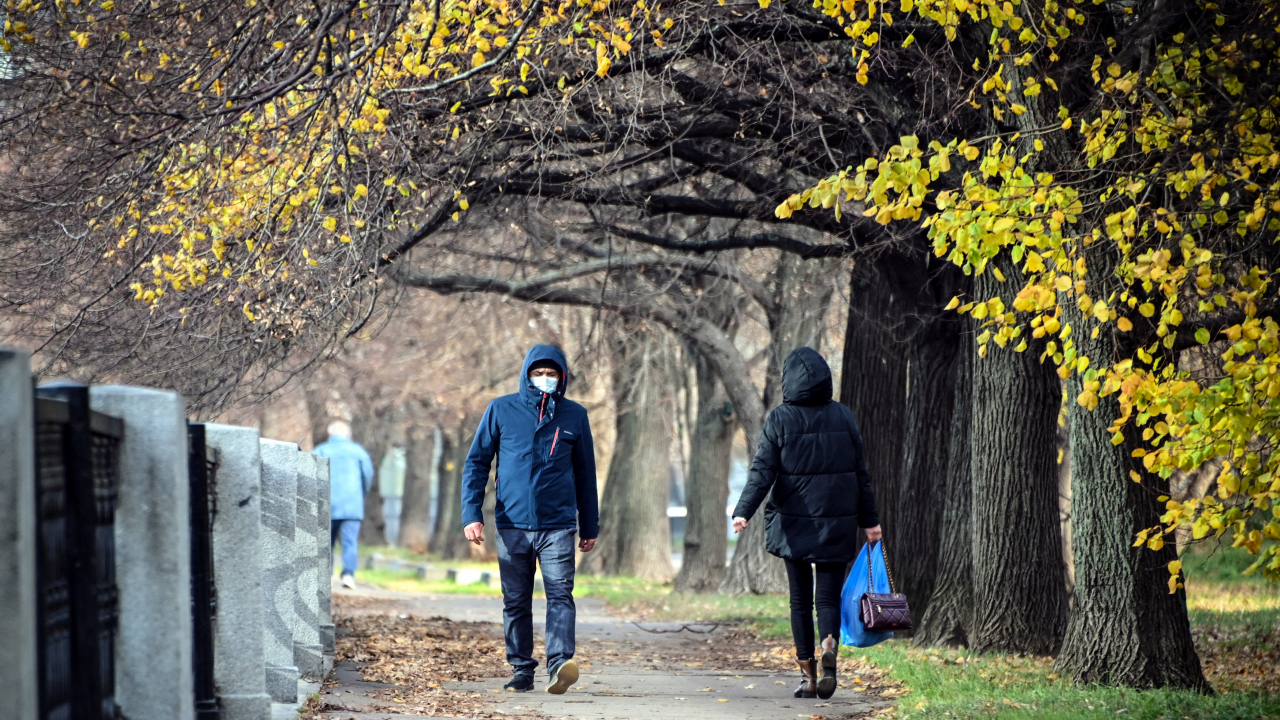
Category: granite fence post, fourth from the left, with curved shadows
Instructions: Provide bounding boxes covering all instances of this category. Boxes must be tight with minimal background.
[260,439,298,702]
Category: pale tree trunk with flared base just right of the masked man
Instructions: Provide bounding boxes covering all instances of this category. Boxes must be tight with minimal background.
[579,331,672,582]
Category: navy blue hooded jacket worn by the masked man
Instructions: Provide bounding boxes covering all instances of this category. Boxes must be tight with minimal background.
[462,345,600,539]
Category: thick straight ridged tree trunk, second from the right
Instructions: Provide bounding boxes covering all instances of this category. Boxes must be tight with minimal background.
[969,256,1068,655]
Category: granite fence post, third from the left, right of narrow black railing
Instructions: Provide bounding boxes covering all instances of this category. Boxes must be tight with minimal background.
[205,424,271,720]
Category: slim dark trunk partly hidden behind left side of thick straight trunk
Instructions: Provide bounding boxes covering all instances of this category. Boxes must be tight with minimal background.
[915,330,977,647]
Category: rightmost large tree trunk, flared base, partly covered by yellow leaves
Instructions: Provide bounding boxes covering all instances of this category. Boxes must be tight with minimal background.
[1057,297,1212,692]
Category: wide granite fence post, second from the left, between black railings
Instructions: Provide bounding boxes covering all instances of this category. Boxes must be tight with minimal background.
[90,386,195,720]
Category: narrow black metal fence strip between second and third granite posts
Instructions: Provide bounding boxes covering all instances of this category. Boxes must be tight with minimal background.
[187,423,221,720]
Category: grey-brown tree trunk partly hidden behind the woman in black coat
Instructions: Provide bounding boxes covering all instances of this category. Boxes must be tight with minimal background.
[719,254,832,594]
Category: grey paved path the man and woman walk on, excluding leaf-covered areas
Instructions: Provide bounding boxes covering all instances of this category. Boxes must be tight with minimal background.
[321,579,892,720]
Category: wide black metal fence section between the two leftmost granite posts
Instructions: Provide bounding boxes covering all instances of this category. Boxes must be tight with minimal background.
[36,383,124,720]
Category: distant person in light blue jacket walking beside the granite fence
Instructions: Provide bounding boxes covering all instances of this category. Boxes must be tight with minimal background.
[315,420,374,588]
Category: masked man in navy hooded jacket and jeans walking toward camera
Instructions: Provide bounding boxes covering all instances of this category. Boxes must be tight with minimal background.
[462,345,600,694]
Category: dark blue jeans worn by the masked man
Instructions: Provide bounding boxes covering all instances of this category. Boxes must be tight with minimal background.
[498,528,577,675]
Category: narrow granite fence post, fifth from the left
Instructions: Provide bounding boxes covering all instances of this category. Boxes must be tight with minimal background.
[293,451,324,679]
